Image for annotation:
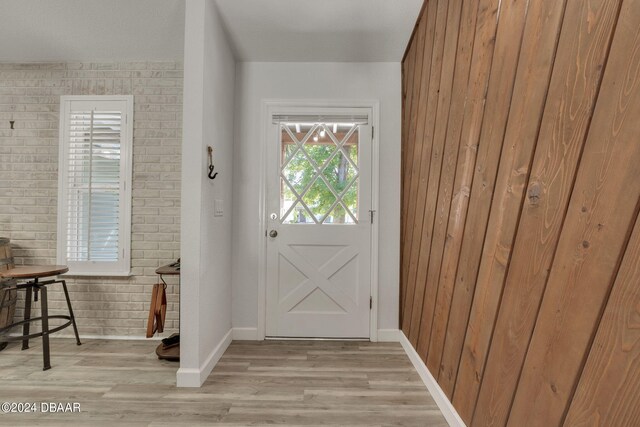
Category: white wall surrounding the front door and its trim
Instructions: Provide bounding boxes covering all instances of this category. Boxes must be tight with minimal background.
[230,62,401,336]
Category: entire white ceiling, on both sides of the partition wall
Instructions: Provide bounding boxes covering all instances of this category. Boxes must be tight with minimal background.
[0,0,423,62]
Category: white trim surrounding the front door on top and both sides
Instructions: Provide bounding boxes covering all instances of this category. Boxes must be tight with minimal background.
[257,99,380,342]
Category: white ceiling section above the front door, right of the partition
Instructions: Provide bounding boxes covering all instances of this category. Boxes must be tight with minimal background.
[216,0,423,62]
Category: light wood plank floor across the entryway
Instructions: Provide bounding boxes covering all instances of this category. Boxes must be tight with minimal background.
[0,338,447,426]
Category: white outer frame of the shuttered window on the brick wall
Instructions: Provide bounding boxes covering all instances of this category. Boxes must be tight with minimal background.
[57,95,133,277]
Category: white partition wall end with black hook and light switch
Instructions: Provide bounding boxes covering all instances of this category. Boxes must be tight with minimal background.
[177,0,235,387]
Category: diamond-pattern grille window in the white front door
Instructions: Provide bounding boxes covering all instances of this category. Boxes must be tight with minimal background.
[280,123,359,224]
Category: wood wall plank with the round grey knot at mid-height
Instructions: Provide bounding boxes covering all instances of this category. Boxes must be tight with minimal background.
[472,0,620,426]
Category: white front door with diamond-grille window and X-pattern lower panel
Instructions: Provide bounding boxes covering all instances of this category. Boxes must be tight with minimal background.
[266,110,372,338]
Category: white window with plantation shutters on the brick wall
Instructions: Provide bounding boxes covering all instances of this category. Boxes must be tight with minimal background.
[58,96,133,276]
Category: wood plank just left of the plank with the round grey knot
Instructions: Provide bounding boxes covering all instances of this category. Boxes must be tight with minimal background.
[453,1,564,423]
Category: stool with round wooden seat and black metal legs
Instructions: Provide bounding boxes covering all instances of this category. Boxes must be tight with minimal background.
[0,265,82,371]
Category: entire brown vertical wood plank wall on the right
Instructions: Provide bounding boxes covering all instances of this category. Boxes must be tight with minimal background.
[400,0,640,427]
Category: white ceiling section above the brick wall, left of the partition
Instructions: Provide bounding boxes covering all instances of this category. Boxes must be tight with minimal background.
[0,0,184,62]
